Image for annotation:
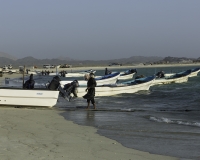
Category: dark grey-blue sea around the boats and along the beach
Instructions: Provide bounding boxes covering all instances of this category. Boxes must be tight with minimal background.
[9,66,200,160]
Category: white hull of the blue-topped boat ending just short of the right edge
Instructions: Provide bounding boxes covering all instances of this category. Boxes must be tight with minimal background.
[152,76,188,85]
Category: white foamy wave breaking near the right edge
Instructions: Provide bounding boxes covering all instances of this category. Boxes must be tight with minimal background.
[149,116,200,127]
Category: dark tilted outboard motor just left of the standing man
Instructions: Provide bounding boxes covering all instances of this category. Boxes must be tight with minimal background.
[64,80,79,97]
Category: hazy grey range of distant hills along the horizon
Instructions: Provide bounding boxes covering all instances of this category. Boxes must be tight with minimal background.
[0,52,200,68]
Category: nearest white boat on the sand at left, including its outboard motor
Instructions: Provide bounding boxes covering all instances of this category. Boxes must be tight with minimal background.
[0,76,70,107]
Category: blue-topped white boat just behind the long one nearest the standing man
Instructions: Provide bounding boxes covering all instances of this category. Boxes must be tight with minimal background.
[60,72,120,87]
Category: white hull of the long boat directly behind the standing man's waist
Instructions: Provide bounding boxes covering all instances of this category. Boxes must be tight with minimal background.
[77,81,152,97]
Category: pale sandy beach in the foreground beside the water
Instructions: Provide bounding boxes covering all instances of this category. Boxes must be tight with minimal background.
[0,107,178,160]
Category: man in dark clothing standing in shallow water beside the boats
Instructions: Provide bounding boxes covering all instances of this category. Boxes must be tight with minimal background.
[83,73,97,109]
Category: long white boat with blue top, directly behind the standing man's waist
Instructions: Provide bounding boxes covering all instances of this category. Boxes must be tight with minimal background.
[71,76,155,97]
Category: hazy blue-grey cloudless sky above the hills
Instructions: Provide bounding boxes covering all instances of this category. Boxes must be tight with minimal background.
[0,0,200,60]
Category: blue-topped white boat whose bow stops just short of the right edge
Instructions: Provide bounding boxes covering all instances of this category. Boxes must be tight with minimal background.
[152,70,191,85]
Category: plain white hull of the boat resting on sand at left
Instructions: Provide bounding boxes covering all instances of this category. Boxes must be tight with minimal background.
[0,88,59,107]
